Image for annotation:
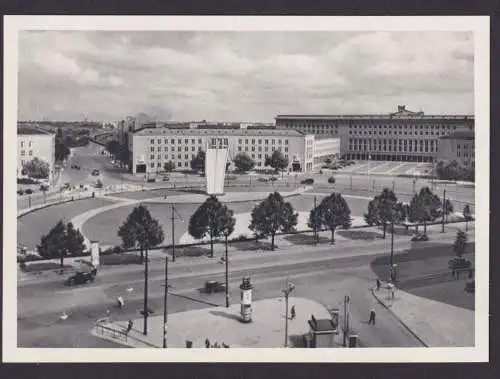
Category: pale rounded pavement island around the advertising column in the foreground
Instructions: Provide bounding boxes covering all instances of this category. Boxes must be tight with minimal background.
[91,297,332,348]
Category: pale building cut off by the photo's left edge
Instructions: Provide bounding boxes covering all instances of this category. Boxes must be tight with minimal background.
[17,126,56,183]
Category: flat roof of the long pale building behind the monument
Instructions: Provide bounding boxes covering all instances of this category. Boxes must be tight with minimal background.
[134,128,305,137]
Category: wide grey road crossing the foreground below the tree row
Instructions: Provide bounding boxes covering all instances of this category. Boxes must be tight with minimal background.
[18,227,470,347]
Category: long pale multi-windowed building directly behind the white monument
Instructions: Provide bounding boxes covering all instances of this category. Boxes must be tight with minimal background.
[131,127,339,174]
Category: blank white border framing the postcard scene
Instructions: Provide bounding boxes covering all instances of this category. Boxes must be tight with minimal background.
[2,16,490,362]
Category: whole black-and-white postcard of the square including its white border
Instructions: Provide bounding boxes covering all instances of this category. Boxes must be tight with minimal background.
[3,16,490,362]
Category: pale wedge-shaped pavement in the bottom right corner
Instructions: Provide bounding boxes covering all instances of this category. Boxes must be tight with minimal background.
[372,283,475,347]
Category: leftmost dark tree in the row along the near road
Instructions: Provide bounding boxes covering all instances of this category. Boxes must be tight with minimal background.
[37,220,85,268]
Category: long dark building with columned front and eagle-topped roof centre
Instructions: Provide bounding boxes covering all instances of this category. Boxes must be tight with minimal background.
[276,105,474,162]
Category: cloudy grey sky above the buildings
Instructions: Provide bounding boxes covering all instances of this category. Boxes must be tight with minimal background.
[18,31,474,122]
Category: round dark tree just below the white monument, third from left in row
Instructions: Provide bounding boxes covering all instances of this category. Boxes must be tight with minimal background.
[188,196,236,257]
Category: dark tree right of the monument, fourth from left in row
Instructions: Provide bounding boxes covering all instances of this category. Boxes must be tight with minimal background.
[249,192,298,250]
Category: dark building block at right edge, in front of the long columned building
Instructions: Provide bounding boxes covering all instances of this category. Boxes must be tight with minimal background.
[437,130,476,168]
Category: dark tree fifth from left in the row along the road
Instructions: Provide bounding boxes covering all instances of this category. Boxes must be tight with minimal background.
[313,193,351,244]
